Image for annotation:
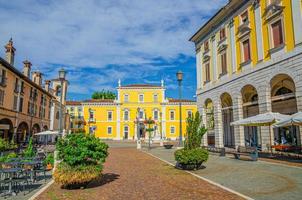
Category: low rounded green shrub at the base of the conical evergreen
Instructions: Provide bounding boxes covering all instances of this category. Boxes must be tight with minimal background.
[174,148,209,165]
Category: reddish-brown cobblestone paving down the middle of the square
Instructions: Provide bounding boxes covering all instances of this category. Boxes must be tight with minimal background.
[37,144,241,200]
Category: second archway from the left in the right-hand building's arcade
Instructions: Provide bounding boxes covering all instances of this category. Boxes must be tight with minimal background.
[220,92,235,147]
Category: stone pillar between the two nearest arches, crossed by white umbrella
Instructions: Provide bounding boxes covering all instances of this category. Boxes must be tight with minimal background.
[258,86,274,150]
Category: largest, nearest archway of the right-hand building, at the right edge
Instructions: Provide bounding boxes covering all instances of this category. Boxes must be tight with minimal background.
[270,74,301,146]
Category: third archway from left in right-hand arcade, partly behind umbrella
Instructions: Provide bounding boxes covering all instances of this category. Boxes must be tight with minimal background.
[241,85,261,147]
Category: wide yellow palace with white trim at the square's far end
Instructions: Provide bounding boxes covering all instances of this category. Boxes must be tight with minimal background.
[67,82,197,140]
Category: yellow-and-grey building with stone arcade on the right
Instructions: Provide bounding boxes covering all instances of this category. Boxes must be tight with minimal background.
[190,0,302,149]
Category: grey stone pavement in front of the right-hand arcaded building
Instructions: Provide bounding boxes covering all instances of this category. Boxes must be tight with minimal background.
[144,147,302,200]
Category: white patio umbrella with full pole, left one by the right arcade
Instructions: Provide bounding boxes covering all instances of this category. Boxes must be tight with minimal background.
[231,112,289,152]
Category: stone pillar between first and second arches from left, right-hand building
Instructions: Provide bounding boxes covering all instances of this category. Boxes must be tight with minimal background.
[213,99,223,147]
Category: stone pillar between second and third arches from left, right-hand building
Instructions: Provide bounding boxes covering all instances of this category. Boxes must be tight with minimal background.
[233,94,245,149]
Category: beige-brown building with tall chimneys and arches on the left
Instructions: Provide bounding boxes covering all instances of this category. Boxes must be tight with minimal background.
[0,39,69,143]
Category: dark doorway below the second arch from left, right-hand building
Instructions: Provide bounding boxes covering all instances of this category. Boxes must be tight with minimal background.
[222,108,235,147]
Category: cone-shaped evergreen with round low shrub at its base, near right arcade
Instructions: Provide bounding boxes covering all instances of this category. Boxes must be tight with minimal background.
[174,112,209,170]
